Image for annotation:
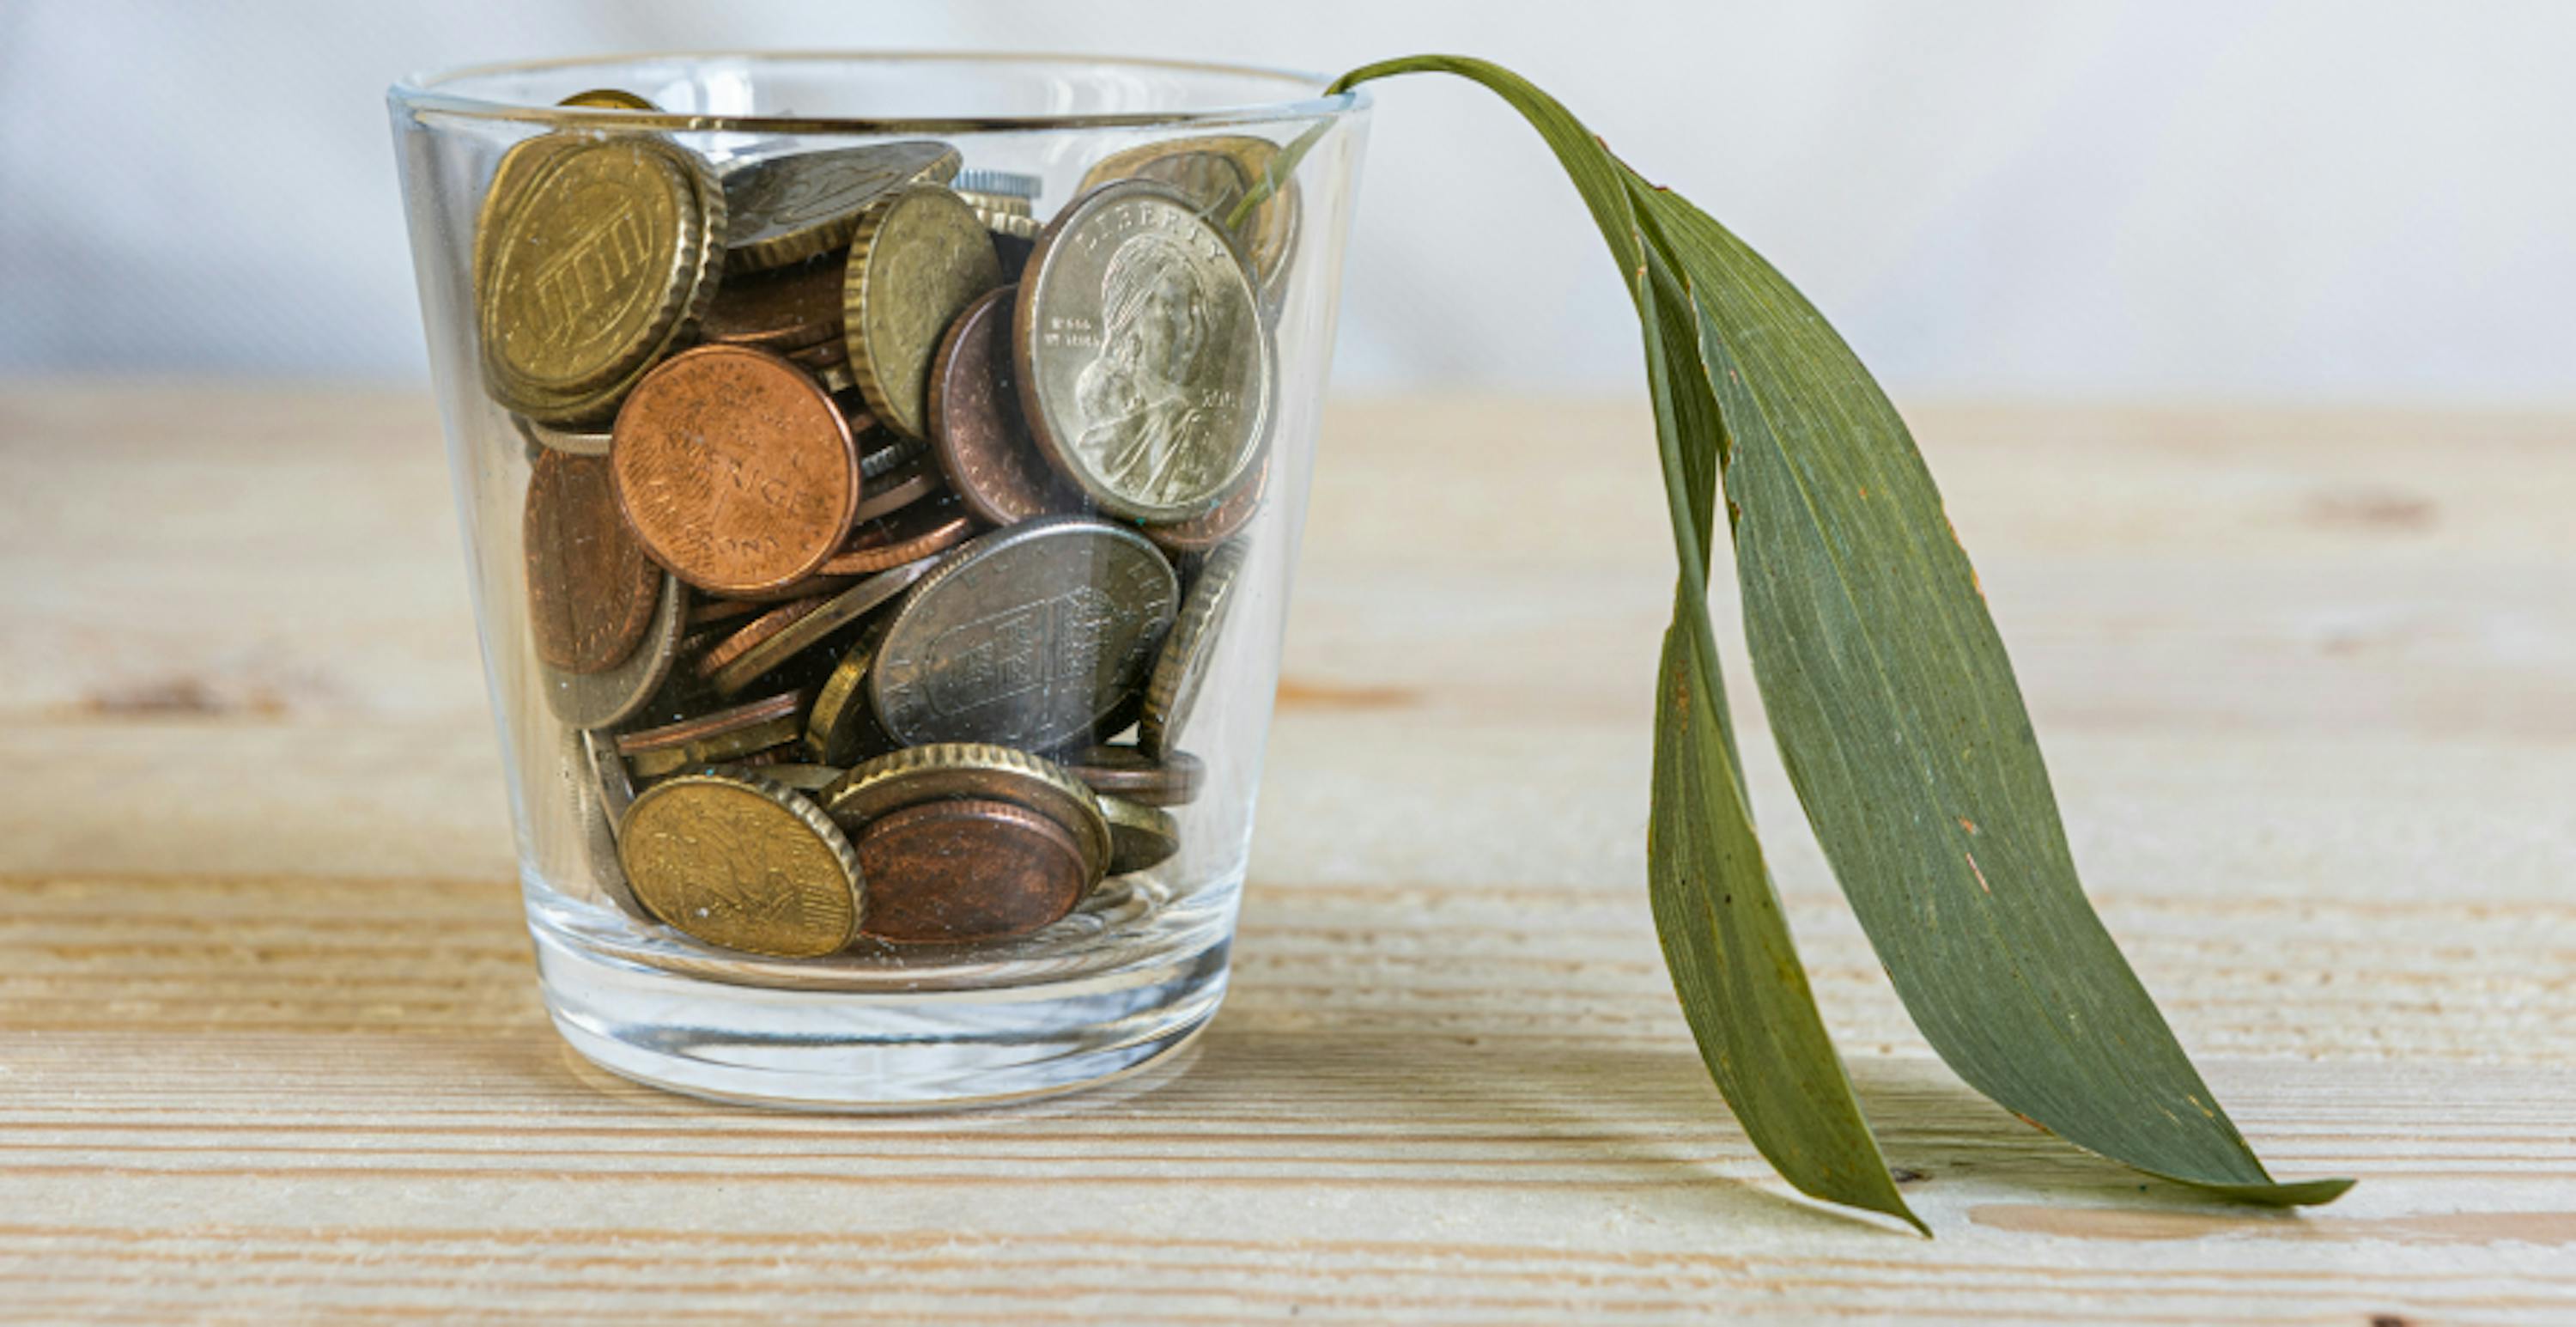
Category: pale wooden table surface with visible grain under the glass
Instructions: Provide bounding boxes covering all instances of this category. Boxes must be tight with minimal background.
[0,381,2576,1324]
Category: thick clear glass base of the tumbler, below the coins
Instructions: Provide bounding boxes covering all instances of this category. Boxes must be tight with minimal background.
[531,902,1231,1111]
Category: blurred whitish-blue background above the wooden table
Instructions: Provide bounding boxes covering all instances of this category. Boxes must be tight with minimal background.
[0,0,2576,405]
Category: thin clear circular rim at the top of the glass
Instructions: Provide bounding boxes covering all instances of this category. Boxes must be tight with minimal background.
[386,49,1370,134]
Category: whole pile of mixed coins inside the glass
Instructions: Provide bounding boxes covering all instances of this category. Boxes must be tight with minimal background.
[474,90,1298,959]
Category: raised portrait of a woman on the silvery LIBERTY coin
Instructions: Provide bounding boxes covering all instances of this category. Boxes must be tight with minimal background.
[1074,234,1231,502]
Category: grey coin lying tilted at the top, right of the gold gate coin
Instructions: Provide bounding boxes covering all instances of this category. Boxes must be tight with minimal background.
[724,139,958,273]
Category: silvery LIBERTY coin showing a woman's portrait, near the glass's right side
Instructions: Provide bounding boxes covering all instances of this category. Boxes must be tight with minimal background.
[1012,183,1275,523]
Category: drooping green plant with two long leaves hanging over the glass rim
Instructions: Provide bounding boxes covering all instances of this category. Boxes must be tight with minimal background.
[1329,57,2352,1227]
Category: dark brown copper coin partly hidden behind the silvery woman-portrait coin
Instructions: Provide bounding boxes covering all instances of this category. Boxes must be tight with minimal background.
[930,286,1079,526]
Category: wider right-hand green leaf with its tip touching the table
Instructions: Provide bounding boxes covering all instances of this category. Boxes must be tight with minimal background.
[1638,191,2352,1203]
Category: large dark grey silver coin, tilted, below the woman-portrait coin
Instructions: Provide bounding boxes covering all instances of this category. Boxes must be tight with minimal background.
[868,518,1180,750]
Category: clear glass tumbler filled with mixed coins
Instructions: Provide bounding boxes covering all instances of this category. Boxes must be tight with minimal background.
[389,54,1368,1111]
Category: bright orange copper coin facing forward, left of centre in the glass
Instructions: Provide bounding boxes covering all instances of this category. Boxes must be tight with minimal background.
[608,345,860,595]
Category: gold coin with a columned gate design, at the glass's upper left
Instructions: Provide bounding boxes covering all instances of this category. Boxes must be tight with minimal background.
[474,134,724,423]
